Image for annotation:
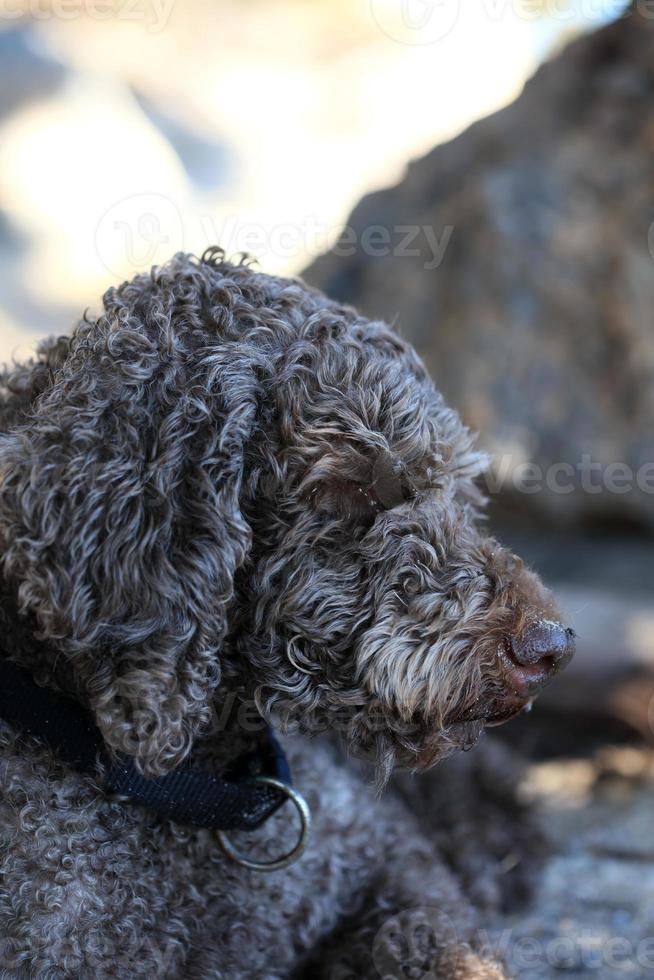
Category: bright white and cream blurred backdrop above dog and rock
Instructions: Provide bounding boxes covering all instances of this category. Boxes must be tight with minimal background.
[0,0,625,360]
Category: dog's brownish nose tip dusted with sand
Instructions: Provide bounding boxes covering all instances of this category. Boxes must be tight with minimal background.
[510,620,575,692]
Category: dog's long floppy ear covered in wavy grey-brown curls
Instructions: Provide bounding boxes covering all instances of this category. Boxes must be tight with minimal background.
[0,293,257,775]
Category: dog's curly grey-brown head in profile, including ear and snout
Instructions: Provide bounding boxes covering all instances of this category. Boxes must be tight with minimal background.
[0,252,572,774]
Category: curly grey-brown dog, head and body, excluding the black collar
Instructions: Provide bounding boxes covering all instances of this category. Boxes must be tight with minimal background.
[0,251,572,980]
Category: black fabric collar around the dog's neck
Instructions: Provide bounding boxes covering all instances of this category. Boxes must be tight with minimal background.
[0,658,291,831]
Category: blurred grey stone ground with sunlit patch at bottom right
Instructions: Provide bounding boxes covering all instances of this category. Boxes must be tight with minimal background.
[488,748,654,980]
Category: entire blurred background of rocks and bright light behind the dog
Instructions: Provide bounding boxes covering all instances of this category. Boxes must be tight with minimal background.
[0,0,654,980]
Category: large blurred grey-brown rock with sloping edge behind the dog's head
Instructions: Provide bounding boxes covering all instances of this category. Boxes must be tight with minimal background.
[305,2,654,528]
